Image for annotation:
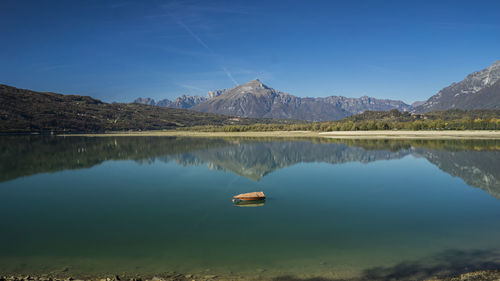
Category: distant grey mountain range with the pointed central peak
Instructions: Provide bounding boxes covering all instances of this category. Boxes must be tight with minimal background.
[134,80,412,121]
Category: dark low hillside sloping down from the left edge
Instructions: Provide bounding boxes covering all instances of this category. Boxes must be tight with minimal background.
[0,84,300,133]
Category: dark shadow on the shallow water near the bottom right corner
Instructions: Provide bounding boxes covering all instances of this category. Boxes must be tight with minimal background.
[274,250,500,281]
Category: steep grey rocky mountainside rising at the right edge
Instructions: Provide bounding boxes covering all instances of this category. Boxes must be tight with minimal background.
[415,60,500,112]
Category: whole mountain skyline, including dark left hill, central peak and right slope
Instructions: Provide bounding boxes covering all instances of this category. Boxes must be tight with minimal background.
[0,61,500,130]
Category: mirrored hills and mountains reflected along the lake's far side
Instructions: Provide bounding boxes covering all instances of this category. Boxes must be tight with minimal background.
[0,136,500,199]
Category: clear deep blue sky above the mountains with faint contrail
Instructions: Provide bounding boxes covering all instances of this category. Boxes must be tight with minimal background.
[0,0,500,102]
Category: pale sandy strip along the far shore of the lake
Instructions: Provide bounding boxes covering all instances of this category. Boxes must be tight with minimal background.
[61,130,500,139]
